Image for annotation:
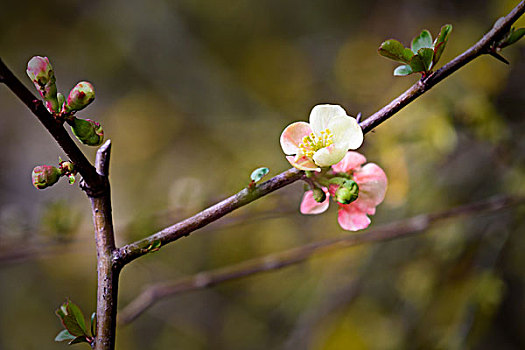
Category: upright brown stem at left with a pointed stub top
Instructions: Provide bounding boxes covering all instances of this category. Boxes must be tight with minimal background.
[90,140,120,350]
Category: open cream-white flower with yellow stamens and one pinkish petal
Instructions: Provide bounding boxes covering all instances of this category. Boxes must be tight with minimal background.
[281,104,363,171]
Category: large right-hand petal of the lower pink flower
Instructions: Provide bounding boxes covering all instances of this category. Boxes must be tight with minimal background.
[353,163,388,215]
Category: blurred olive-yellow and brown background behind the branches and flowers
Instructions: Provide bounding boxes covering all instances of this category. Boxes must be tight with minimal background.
[0,0,525,350]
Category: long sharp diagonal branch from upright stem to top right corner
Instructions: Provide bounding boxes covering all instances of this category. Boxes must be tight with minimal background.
[116,1,525,265]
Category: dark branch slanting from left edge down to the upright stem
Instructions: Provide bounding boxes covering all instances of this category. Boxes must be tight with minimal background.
[0,58,104,192]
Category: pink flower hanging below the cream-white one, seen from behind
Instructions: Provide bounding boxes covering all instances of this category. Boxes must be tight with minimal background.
[300,151,387,231]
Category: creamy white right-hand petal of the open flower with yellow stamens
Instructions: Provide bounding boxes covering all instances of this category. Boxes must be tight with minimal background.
[328,114,364,150]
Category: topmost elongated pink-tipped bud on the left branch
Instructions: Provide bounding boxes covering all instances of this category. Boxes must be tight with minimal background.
[26,56,59,113]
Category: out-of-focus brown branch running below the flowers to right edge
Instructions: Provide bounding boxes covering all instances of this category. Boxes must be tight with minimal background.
[119,196,525,324]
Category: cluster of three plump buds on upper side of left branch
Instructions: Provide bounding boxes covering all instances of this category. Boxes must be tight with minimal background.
[27,56,104,146]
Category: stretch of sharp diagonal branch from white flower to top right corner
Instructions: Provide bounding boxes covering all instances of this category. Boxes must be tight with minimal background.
[360,1,525,132]
